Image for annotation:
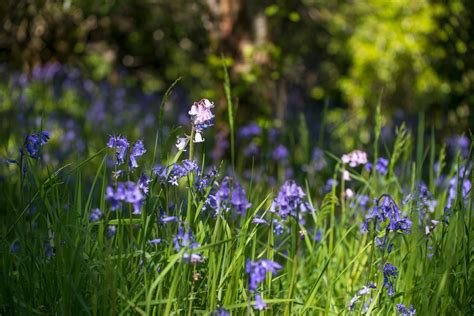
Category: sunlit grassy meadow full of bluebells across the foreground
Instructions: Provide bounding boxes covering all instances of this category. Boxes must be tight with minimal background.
[0,66,474,315]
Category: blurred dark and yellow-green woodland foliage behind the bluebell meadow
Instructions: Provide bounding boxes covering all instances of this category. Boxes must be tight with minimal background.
[0,0,474,148]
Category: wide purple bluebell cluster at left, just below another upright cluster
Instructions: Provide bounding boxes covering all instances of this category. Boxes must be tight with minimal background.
[105,181,145,215]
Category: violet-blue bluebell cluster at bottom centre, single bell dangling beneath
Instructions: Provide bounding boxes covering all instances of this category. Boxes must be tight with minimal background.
[245,259,282,310]
